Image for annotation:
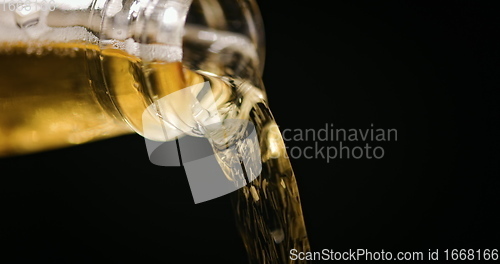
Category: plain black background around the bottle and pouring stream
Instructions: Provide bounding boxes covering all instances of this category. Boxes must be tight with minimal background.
[0,1,500,263]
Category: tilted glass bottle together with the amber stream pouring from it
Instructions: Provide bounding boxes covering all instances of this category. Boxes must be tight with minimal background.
[0,0,309,264]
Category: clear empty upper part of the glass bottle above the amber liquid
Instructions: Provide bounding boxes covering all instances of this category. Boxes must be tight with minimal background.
[0,0,264,77]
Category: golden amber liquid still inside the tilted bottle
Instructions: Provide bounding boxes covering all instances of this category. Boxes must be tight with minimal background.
[0,43,191,156]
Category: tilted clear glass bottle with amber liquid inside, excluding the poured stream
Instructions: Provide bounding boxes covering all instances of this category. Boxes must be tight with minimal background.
[0,0,264,156]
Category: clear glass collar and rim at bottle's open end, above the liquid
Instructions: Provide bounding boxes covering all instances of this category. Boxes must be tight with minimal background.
[94,0,265,71]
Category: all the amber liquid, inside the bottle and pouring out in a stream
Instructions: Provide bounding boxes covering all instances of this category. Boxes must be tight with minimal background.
[0,43,309,264]
